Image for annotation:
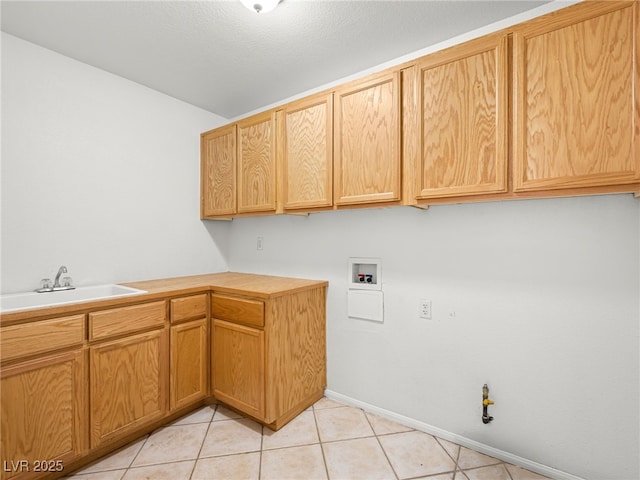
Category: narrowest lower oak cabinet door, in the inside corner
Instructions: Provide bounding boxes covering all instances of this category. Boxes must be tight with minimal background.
[170,318,209,410]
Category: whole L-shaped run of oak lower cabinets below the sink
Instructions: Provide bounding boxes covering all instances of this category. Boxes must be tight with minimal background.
[0,273,327,480]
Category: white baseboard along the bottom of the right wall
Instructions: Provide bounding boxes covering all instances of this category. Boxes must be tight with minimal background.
[325,390,584,480]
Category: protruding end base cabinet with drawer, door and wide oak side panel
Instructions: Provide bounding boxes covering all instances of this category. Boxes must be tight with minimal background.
[211,284,326,430]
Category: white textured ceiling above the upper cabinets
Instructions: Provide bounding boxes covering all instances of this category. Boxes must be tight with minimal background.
[1,0,548,118]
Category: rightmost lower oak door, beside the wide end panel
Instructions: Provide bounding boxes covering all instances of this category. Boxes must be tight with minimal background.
[211,319,265,419]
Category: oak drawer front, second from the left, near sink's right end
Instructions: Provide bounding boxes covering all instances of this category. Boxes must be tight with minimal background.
[89,302,167,340]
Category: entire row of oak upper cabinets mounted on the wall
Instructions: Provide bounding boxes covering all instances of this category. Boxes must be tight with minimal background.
[202,0,640,214]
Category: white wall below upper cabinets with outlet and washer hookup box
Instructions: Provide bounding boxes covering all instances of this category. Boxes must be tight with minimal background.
[228,195,640,480]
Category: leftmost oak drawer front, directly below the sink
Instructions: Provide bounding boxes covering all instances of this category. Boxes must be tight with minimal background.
[0,315,85,361]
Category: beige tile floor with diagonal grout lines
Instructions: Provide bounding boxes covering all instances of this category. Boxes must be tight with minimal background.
[67,398,546,480]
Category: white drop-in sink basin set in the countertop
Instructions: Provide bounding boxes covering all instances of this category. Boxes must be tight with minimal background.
[0,283,146,313]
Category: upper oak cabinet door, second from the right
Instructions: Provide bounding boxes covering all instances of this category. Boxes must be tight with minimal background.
[417,33,508,199]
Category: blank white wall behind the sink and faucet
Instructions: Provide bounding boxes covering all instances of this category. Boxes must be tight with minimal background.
[1,33,228,293]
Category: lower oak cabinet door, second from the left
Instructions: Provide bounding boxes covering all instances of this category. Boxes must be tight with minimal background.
[90,329,169,448]
